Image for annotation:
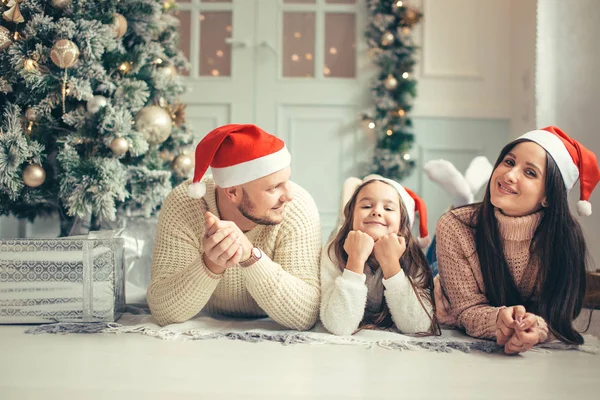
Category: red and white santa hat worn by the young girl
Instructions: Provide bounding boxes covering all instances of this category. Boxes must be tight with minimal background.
[342,174,431,248]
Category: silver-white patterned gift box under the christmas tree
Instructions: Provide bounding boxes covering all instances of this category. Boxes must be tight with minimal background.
[0,231,125,324]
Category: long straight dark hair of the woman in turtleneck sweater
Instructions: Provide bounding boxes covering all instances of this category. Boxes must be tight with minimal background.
[470,140,587,344]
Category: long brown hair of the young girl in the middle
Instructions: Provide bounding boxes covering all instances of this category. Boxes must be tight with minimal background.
[327,179,439,334]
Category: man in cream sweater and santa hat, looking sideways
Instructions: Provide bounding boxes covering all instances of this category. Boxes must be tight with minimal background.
[148,124,321,330]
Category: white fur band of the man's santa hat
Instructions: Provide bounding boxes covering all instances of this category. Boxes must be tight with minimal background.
[211,146,292,188]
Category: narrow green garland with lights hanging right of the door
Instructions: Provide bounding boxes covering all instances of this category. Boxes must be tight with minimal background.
[362,0,422,180]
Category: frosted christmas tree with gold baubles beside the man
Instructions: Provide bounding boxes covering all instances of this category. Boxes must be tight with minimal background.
[0,0,193,235]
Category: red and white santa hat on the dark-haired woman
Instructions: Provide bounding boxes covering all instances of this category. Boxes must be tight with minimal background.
[517,126,600,216]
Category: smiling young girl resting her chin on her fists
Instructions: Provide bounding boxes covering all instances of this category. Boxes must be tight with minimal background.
[321,175,437,335]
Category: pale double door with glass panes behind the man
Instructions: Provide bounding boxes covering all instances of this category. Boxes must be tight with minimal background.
[183,0,369,236]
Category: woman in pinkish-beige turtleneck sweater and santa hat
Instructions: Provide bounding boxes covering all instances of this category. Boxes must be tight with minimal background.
[436,126,600,354]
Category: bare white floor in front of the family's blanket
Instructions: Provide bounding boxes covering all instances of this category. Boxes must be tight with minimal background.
[0,311,600,400]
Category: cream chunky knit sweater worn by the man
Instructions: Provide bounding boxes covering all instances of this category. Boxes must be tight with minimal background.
[148,177,321,330]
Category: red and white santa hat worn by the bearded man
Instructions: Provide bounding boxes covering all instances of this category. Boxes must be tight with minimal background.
[188,124,291,199]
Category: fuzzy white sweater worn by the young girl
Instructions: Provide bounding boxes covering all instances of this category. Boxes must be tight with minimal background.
[321,244,433,335]
